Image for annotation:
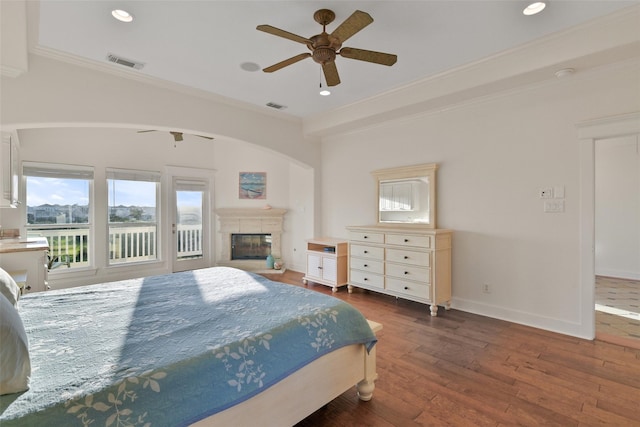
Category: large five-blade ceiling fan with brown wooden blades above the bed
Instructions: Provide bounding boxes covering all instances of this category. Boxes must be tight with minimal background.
[256,9,398,86]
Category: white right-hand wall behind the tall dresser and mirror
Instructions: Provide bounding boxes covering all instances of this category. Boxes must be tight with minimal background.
[322,62,640,335]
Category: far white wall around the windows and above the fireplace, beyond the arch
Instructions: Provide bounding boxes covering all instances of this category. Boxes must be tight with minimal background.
[0,128,313,288]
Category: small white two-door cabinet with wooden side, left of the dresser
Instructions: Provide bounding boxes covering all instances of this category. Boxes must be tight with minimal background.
[302,237,349,292]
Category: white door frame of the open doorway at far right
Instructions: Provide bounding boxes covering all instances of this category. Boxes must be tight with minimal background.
[576,112,640,339]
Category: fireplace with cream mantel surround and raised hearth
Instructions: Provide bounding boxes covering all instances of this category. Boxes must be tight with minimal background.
[216,208,287,273]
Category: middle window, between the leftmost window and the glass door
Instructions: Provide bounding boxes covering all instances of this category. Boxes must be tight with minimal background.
[107,169,160,265]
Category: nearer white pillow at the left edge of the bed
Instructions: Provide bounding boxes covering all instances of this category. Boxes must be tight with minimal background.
[0,295,31,395]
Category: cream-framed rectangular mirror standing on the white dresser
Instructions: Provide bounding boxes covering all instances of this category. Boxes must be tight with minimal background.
[371,163,438,228]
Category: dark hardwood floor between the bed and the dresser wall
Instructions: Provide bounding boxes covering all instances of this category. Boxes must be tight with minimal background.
[266,271,640,427]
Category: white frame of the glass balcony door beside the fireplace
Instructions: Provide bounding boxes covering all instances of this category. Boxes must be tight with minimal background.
[165,166,216,272]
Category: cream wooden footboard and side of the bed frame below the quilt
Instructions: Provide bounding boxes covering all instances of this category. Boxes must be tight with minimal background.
[192,320,382,427]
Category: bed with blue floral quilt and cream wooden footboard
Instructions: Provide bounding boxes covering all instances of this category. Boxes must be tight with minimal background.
[0,267,380,427]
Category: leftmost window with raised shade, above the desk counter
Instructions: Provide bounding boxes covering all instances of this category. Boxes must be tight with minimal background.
[23,163,93,268]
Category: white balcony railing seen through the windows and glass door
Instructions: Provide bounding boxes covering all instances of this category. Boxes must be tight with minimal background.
[28,224,203,268]
